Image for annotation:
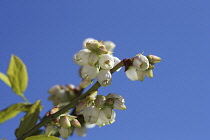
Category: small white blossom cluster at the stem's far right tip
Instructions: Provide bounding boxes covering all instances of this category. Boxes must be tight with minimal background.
[126,54,161,81]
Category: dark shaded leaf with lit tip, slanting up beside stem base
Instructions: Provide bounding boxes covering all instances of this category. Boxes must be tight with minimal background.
[15,100,42,138]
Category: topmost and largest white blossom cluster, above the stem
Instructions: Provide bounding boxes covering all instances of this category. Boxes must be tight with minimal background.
[74,38,120,88]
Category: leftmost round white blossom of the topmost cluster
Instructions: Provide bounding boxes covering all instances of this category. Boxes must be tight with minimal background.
[74,49,90,65]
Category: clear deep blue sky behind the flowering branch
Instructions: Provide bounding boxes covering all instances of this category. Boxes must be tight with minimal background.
[0,0,210,140]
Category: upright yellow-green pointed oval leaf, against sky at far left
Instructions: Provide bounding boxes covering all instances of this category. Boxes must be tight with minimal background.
[7,55,28,96]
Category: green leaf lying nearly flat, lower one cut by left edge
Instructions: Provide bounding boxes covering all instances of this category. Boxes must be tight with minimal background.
[0,103,30,124]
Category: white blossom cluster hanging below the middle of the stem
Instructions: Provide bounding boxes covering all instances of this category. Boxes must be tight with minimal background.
[76,91,126,127]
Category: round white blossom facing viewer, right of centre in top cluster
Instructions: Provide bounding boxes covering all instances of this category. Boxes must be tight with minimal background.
[98,54,114,70]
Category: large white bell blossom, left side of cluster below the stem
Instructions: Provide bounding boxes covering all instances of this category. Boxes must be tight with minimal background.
[83,105,99,124]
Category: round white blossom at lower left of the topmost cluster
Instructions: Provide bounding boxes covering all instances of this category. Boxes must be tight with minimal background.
[81,64,99,80]
